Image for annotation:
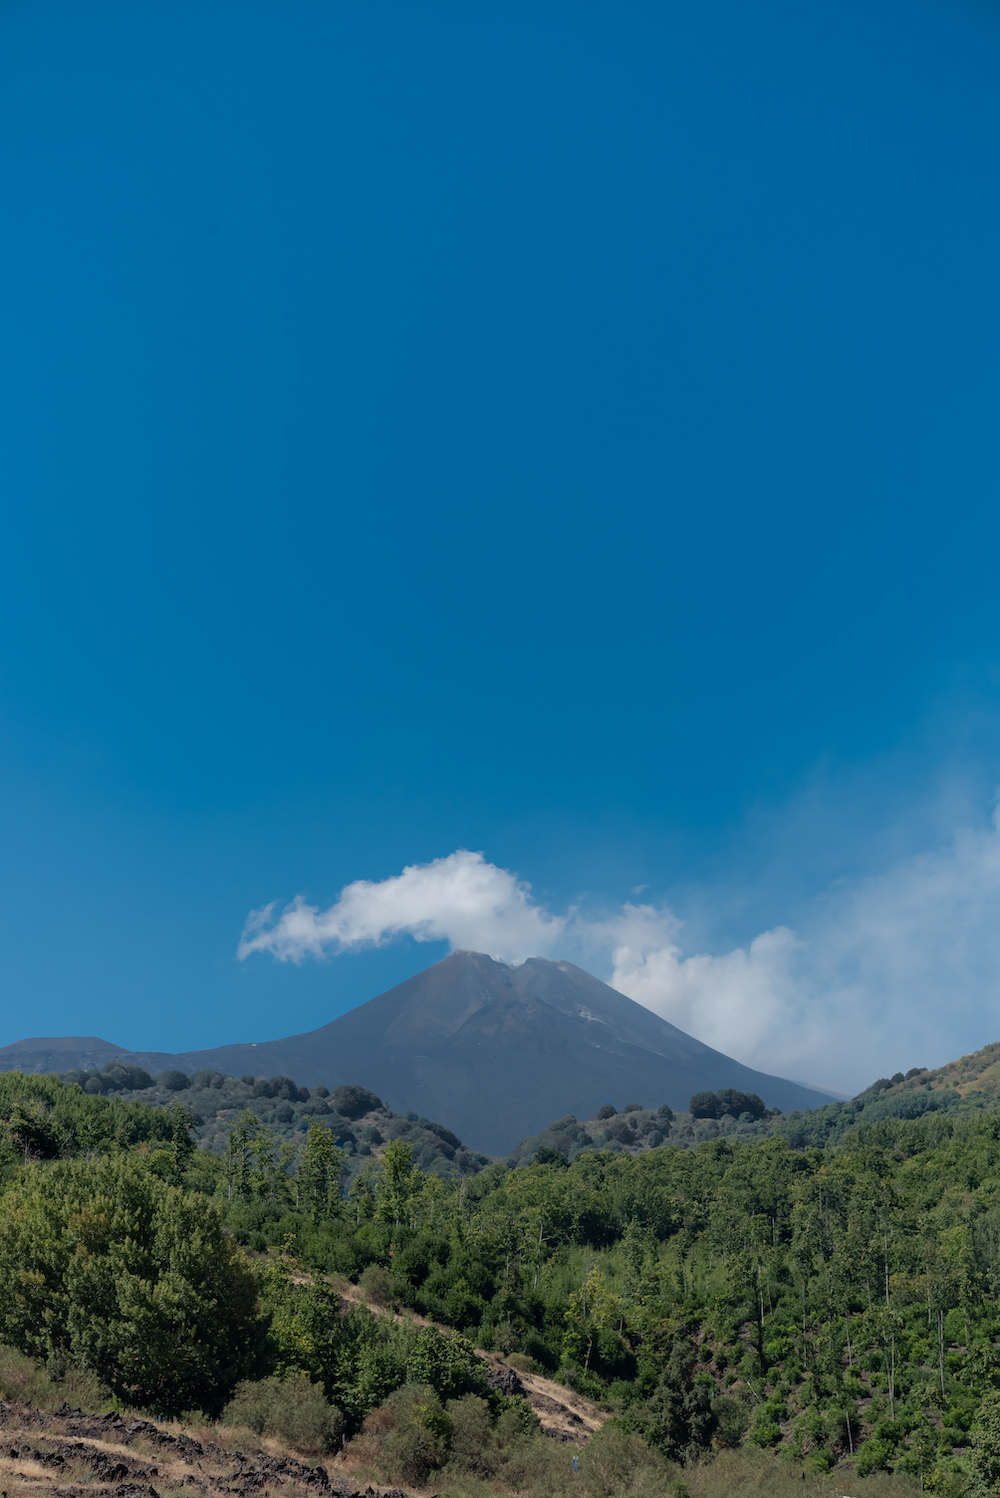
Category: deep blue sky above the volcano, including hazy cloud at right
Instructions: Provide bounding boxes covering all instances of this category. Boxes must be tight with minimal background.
[0,0,1000,1086]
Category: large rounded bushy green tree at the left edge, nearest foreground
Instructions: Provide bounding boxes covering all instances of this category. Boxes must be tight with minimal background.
[0,1155,268,1414]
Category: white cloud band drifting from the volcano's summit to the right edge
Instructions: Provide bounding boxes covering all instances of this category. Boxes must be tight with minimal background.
[240,818,1000,1088]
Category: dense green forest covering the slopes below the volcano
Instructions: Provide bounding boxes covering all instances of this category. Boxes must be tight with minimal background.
[0,1067,1000,1494]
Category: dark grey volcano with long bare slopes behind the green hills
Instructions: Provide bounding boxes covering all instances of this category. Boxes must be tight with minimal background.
[0,951,829,1155]
